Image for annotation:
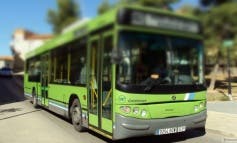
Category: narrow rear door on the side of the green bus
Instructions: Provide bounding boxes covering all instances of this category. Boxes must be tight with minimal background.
[41,54,49,107]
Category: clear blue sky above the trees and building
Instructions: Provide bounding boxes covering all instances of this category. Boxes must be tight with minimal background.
[0,0,199,56]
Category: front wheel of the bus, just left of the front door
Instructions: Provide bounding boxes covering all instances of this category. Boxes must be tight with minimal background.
[70,99,85,132]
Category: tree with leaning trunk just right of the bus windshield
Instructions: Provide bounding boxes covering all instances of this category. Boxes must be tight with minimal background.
[201,1,237,90]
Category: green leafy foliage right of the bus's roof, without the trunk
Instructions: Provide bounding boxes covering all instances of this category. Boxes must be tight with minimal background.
[177,0,237,64]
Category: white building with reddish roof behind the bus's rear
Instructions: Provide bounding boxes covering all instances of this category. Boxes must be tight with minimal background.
[10,29,53,72]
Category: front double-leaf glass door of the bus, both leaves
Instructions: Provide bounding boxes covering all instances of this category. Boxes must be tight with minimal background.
[88,32,113,133]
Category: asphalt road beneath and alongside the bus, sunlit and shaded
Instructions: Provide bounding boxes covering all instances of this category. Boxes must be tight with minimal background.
[0,78,231,143]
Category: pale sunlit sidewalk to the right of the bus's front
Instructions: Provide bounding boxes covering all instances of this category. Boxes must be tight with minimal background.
[206,101,237,138]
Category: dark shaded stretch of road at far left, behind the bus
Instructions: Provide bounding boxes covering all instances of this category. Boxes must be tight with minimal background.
[0,76,25,105]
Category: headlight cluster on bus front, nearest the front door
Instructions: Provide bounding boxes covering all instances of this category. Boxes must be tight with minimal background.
[120,106,148,118]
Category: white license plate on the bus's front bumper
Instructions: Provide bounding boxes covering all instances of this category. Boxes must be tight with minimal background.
[155,126,186,135]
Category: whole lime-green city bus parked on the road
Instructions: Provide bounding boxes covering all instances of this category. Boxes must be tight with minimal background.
[24,5,207,140]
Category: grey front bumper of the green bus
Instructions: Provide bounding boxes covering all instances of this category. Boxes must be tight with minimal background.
[113,110,207,140]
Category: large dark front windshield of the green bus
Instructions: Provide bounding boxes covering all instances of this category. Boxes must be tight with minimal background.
[117,32,204,85]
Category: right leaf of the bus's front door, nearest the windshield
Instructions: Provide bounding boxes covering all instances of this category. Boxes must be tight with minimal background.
[99,32,113,133]
